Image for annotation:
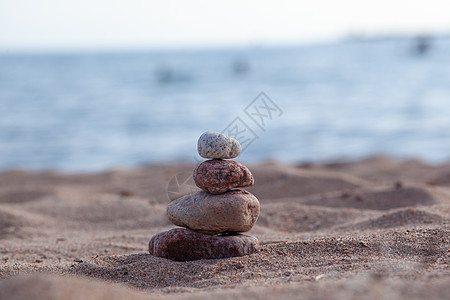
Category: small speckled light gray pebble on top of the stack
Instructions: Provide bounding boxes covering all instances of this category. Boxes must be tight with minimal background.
[197,131,241,159]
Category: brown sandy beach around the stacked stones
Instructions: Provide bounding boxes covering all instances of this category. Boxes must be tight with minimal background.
[0,157,450,300]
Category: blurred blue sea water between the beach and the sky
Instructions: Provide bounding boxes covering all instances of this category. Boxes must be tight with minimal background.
[0,37,450,172]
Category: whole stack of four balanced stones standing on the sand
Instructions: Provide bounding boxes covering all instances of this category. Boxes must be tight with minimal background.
[149,131,259,261]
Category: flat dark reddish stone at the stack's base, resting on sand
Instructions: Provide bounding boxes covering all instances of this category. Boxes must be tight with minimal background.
[148,228,258,261]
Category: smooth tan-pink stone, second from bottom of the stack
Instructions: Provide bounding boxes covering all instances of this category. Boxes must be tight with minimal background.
[167,190,260,234]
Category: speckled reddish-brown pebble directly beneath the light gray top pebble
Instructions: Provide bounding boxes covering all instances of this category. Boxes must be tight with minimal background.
[194,160,254,194]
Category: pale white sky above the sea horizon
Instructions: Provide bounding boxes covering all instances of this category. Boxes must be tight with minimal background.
[0,0,450,51]
